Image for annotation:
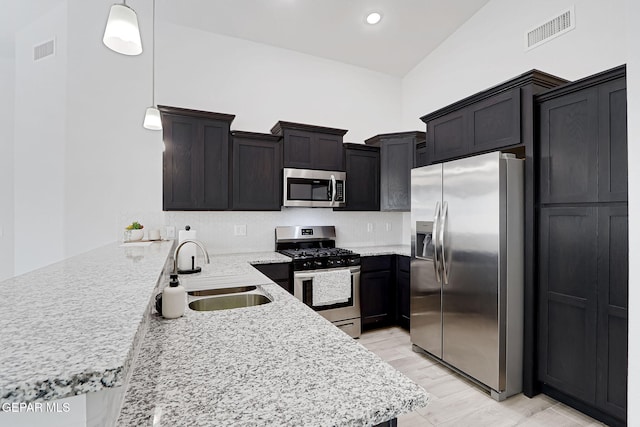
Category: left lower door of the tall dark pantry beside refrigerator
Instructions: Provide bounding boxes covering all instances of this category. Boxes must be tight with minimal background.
[538,207,598,403]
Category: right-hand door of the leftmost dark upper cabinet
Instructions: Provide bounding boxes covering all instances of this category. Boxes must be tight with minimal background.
[199,120,229,210]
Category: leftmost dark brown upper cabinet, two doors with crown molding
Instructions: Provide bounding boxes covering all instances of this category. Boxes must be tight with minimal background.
[158,106,235,211]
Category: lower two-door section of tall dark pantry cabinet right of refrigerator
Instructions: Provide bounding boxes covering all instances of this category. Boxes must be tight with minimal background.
[538,203,629,425]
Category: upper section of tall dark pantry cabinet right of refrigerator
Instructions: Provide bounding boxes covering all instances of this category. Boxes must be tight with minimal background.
[537,67,627,203]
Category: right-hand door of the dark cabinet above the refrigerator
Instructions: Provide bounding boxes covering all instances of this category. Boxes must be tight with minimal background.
[469,88,520,153]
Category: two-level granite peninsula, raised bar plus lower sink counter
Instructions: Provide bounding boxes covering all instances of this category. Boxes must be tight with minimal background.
[0,242,429,426]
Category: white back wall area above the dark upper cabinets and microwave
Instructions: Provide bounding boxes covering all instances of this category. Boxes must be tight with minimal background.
[156,23,400,142]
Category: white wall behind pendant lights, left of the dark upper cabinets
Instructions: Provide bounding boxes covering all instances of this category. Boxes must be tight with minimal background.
[64,0,162,256]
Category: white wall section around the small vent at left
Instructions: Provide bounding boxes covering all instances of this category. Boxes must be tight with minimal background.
[14,2,67,274]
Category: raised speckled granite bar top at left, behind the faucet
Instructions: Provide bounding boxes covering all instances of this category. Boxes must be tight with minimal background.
[0,242,172,403]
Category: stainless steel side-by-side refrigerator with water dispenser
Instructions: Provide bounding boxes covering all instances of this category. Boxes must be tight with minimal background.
[411,152,524,400]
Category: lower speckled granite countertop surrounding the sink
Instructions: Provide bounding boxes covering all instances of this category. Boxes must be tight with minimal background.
[117,253,429,427]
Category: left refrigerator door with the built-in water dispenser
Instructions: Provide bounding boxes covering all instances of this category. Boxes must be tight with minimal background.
[410,165,442,358]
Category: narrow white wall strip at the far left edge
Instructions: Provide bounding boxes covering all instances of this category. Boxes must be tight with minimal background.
[0,57,15,281]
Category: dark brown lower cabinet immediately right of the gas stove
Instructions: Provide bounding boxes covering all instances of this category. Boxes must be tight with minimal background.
[360,255,395,329]
